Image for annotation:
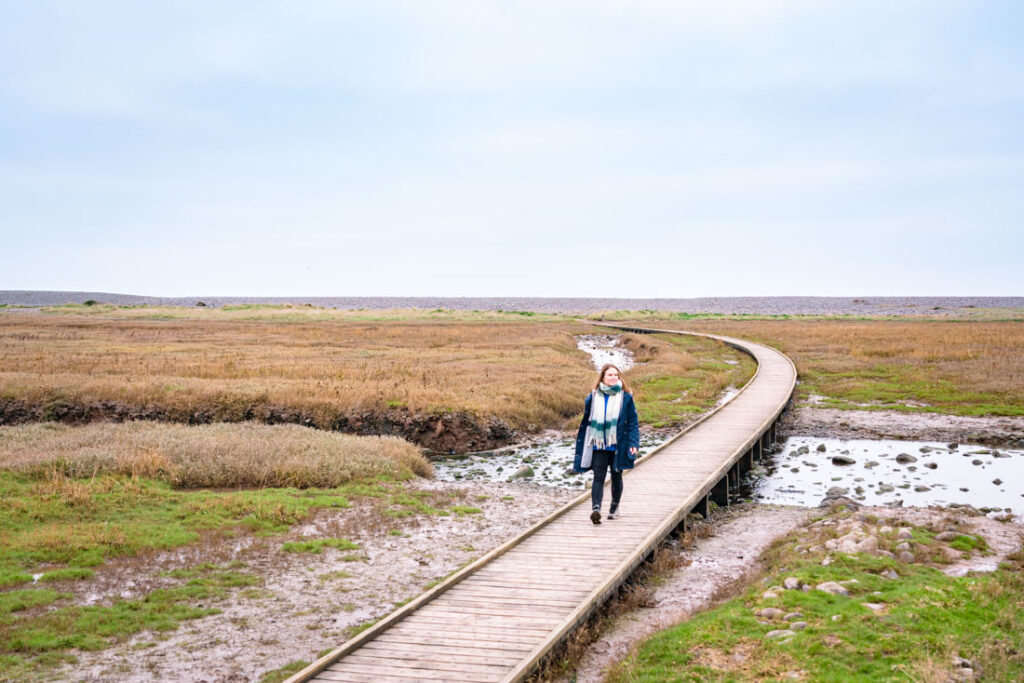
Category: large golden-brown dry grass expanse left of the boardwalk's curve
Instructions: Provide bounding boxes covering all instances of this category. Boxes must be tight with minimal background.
[0,312,753,430]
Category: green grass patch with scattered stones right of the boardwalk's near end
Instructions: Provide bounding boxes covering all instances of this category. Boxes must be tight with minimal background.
[610,516,1024,682]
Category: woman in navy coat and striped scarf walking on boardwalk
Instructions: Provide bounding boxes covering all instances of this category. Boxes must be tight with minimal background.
[572,362,640,524]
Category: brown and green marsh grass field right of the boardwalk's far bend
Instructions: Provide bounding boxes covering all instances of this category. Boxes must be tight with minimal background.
[634,319,1024,415]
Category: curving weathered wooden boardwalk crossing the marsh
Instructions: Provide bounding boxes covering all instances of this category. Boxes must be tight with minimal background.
[287,326,797,683]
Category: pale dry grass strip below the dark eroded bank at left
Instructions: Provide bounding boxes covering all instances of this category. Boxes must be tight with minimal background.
[0,422,433,489]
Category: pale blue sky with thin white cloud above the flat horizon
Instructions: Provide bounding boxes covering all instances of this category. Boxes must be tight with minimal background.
[0,0,1024,297]
